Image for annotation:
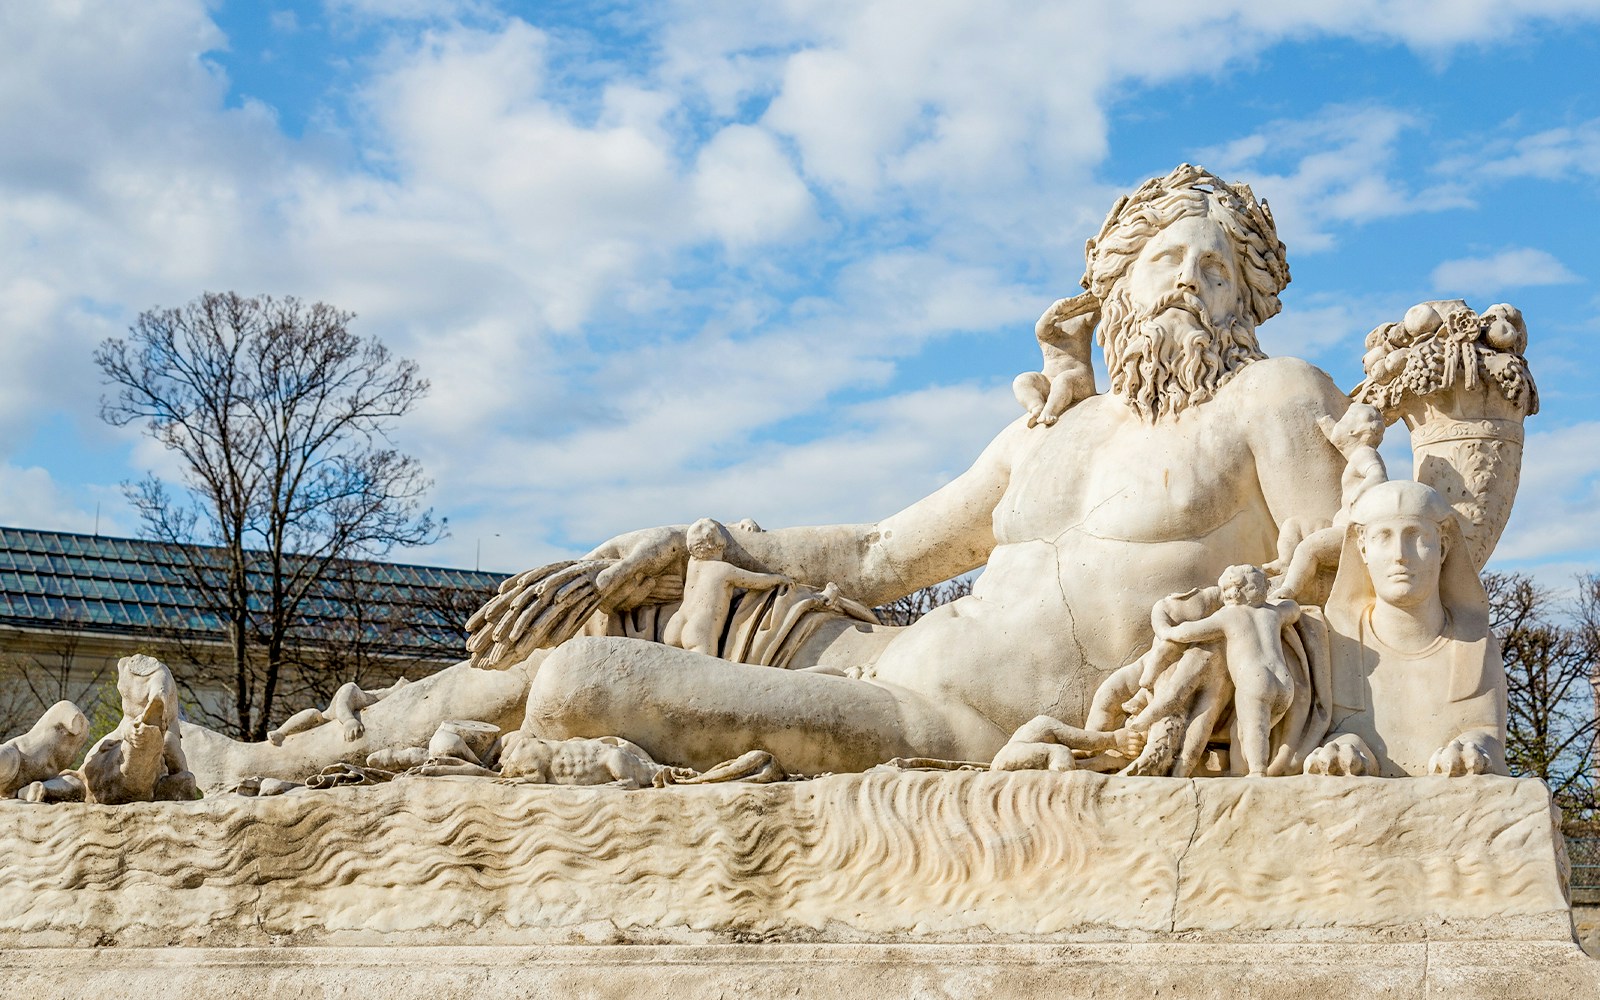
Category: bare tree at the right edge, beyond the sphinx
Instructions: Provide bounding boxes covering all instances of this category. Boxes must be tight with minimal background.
[1483,573,1600,814]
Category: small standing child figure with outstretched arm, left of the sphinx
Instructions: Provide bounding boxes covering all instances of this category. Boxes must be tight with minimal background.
[1157,565,1299,778]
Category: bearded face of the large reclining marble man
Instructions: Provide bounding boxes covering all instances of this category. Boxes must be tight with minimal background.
[1099,214,1261,419]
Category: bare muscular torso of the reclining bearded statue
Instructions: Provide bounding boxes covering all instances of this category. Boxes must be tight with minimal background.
[872,360,1342,733]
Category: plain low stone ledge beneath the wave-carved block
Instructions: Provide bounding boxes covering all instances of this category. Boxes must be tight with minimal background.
[0,941,1600,1000]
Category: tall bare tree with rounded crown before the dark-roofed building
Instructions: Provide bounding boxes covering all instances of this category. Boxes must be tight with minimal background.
[94,293,440,739]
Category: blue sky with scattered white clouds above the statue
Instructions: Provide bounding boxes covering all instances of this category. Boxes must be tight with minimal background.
[0,0,1600,584]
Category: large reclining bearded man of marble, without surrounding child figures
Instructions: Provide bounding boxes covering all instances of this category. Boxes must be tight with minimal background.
[474,165,1349,773]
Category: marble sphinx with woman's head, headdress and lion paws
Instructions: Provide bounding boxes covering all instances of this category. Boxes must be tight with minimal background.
[1306,480,1506,778]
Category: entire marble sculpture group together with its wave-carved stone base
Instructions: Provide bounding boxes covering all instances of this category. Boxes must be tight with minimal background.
[0,165,1600,997]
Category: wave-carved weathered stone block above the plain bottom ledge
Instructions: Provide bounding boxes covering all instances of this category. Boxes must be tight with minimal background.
[0,771,1571,947]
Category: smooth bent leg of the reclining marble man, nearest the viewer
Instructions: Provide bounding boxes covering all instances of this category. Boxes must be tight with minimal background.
[523,637,1005,773]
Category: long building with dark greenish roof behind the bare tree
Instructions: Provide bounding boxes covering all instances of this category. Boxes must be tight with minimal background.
[0,528,501,739]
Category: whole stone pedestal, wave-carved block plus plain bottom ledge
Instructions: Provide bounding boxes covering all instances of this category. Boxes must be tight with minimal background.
[0,770,1600,1000]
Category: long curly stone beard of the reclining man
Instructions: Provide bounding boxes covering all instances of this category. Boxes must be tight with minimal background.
[1098,290,1266,422]
